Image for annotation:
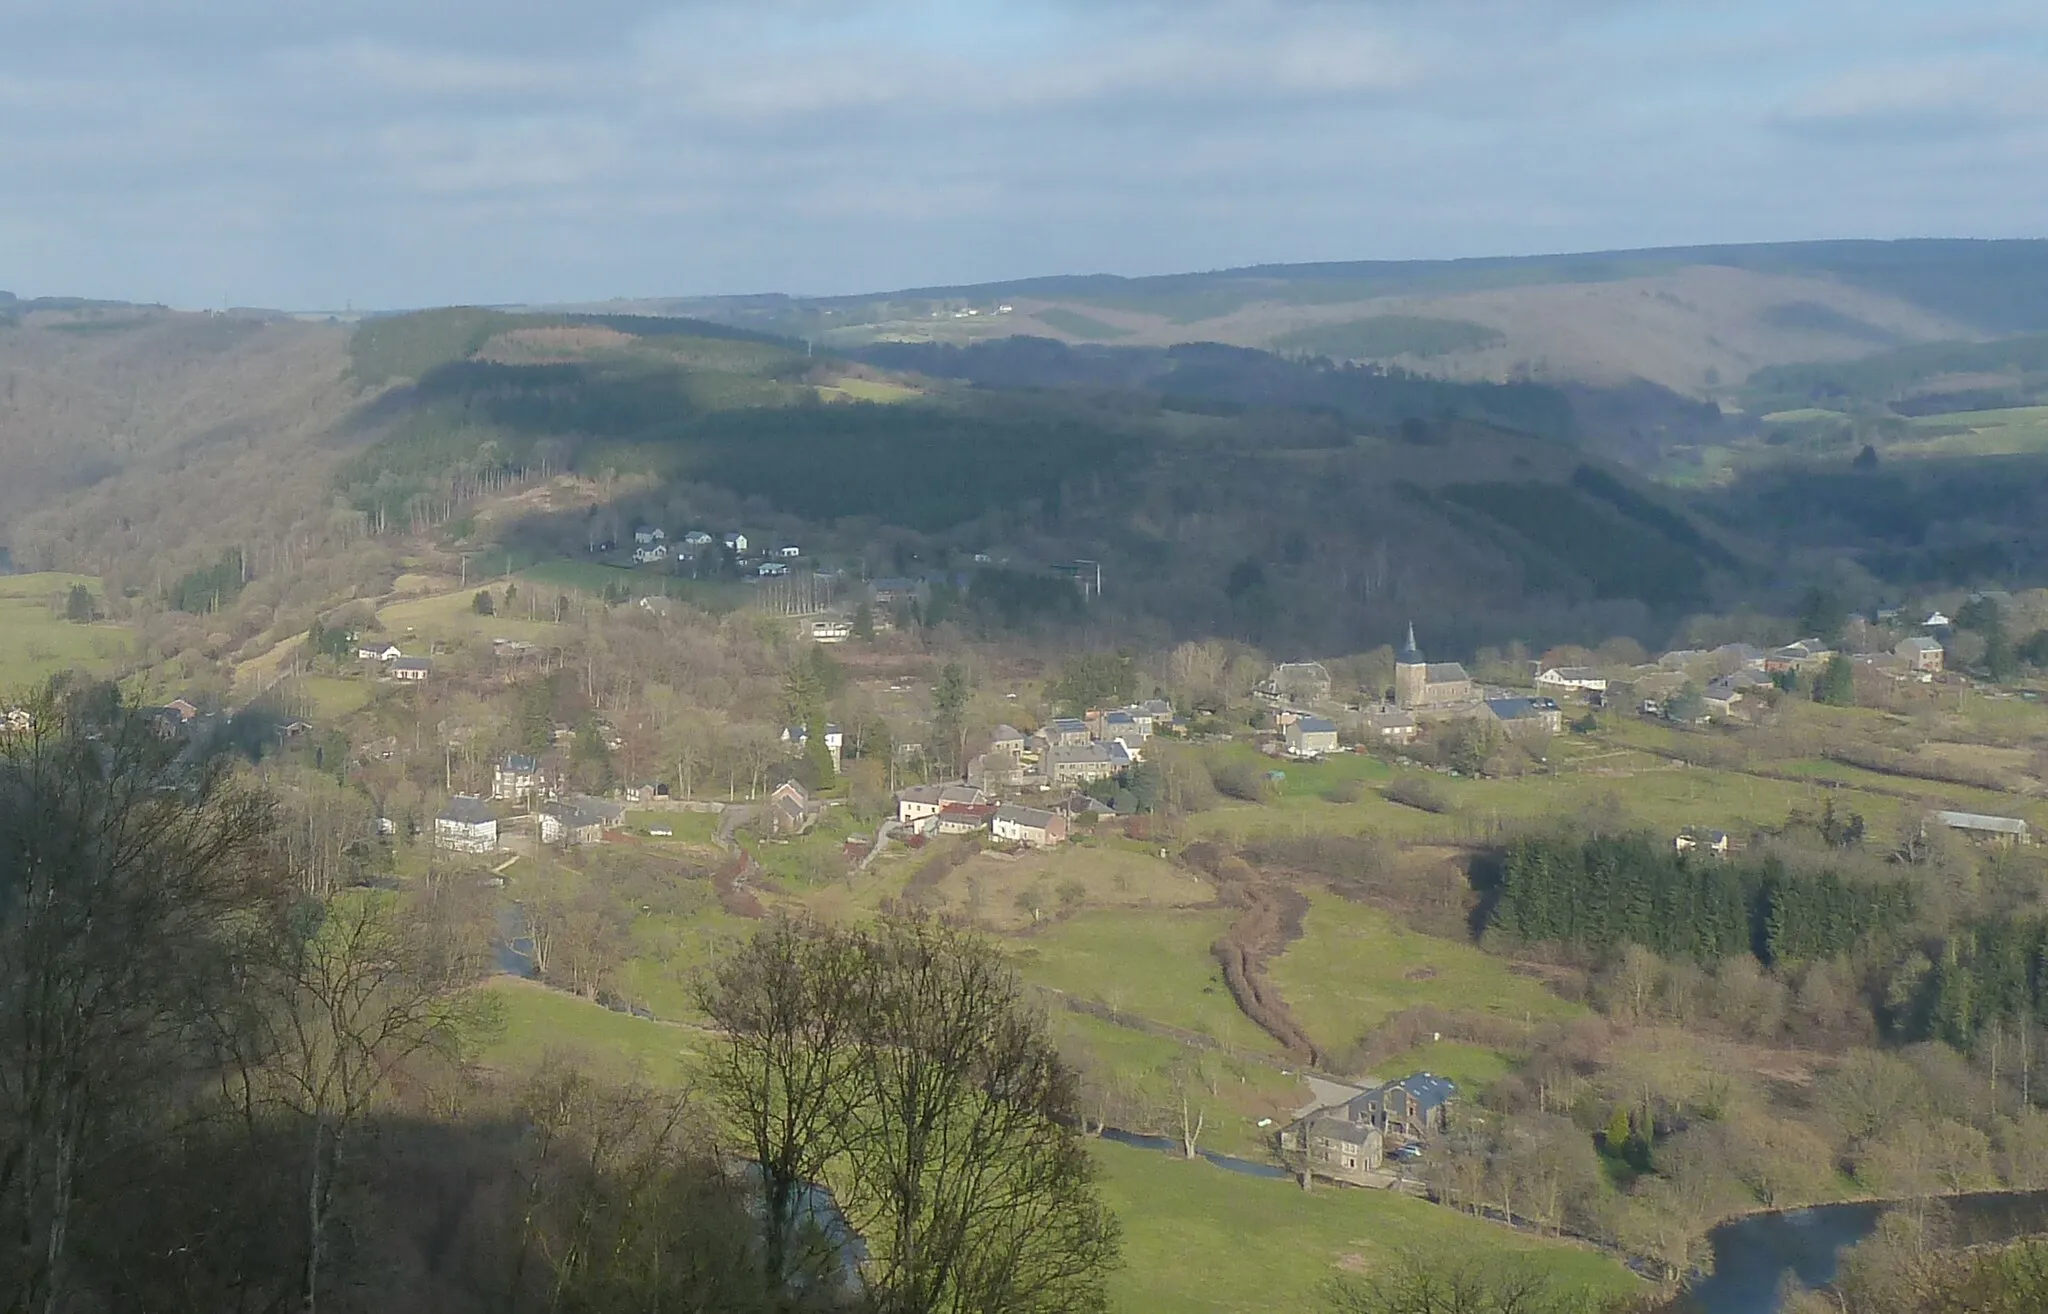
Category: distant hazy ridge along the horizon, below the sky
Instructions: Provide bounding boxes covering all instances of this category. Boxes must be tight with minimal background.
[577,239,2048,395]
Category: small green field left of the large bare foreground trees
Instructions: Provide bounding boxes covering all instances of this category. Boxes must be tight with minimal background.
[477,976,696,1085]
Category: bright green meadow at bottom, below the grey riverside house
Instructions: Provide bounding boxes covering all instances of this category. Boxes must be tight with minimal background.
[1094,1142,1642,1314]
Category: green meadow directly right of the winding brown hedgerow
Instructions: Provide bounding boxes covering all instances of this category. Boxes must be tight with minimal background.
[1268,892,1583,1050]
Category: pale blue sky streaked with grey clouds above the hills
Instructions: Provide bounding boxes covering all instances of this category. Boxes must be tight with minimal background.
[0,0,2048,309]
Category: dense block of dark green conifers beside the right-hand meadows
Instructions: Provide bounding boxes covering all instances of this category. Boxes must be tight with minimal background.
[1487,833,1915,964]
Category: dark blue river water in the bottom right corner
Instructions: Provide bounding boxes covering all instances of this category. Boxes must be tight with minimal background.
[1692,1191,2048,1314]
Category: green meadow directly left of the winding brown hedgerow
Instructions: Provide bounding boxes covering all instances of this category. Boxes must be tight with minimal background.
[1014,909,1278,1052]
